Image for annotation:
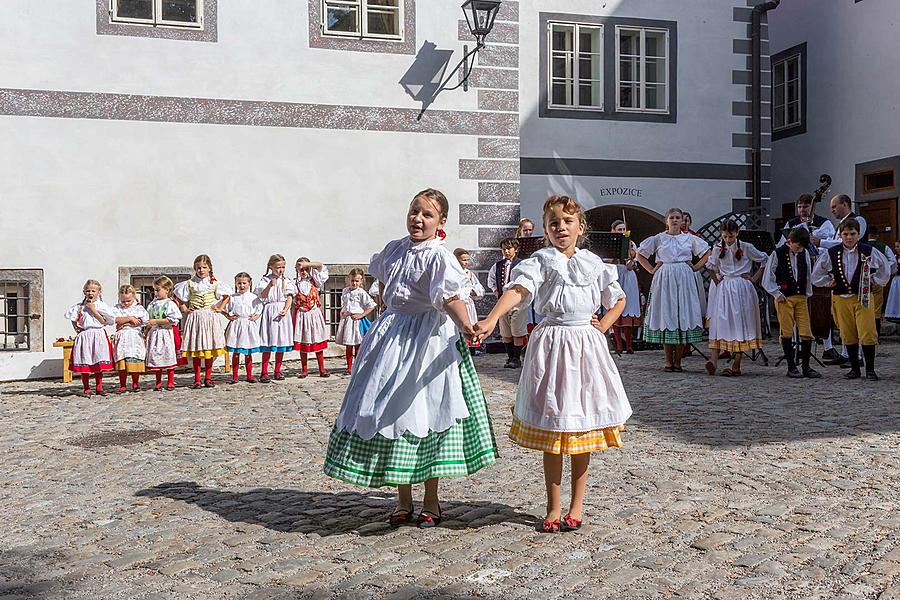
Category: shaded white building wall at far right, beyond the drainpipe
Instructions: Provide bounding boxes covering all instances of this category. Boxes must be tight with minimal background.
[769,0,900,216]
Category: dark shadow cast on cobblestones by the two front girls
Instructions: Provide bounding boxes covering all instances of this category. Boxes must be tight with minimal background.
[135,481,537,536]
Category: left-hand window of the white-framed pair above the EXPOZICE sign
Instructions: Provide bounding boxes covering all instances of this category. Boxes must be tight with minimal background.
[548,23,603,110]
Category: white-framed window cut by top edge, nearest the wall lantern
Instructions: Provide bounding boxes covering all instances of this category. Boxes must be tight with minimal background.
[322,0,403,40]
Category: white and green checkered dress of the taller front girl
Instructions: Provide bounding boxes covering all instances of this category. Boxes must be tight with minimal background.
[325,237,497,487]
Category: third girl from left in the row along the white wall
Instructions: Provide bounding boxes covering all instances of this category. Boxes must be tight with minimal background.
[146,277,187,391]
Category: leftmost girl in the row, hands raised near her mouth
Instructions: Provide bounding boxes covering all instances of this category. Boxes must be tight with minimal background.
[65,279,116,396]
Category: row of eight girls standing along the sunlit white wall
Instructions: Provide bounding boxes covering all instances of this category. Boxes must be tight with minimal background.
[65,254,376,394]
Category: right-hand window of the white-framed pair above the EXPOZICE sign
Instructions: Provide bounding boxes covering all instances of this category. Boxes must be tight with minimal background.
[616,27,669,113]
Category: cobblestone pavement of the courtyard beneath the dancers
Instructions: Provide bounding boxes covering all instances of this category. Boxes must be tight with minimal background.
[0,344,900,600]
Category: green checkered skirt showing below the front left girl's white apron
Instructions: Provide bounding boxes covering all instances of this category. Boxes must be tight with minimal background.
[325,339,499,488]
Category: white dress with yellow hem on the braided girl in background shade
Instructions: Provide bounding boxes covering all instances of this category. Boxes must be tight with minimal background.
[707,241,769,352]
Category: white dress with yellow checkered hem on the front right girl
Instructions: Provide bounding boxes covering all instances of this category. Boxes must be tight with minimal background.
[506,248,631,454]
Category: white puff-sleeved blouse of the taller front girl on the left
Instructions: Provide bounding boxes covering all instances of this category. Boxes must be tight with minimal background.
[369,237,472,314]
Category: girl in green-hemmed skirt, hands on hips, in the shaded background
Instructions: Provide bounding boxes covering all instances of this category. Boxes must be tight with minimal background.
[636,208,709,372]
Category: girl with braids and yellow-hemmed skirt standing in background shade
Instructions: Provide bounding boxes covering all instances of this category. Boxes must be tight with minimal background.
[706,219,769,377]
